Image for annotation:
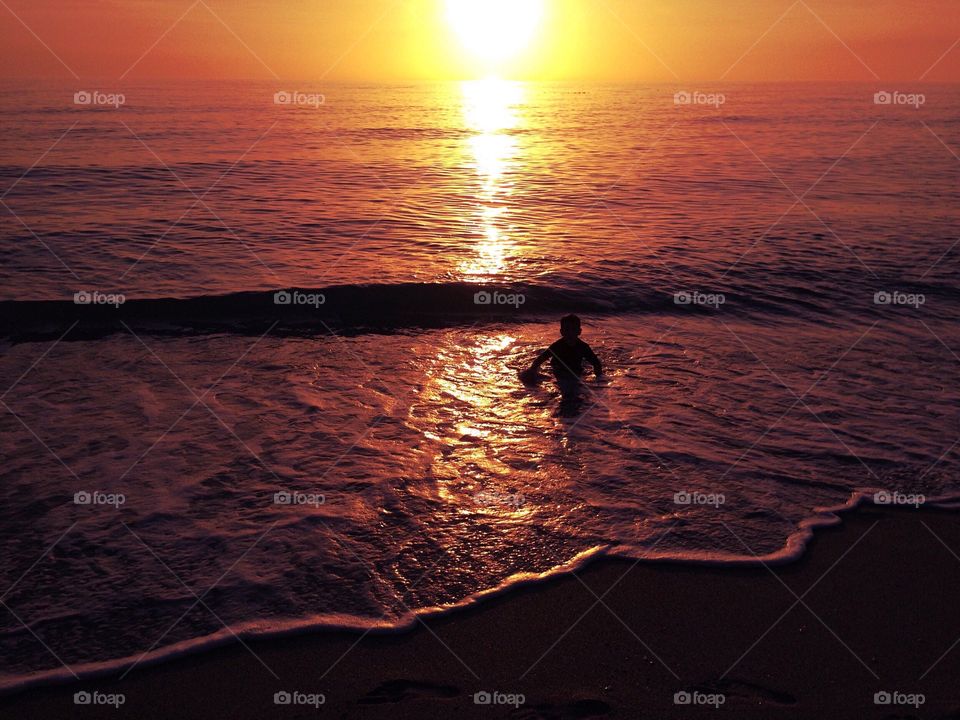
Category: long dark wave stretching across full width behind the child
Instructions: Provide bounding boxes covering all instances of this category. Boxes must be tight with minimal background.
[0,278,960,343]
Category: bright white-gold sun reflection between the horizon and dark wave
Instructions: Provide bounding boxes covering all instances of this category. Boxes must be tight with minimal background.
[458,78,526,280]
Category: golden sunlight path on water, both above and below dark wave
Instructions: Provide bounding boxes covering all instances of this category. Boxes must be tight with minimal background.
[417,78,543,520]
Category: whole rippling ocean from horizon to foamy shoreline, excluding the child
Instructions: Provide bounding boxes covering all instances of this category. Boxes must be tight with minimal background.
[0,79,960,690]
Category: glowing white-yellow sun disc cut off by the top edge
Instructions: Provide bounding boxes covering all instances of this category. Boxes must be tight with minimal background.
[447,0,544,63]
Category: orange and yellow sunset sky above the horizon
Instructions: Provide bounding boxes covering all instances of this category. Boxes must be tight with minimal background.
[0,0,960,82]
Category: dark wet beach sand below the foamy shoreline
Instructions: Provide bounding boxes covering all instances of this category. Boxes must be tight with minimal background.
[0,507,960,720]
